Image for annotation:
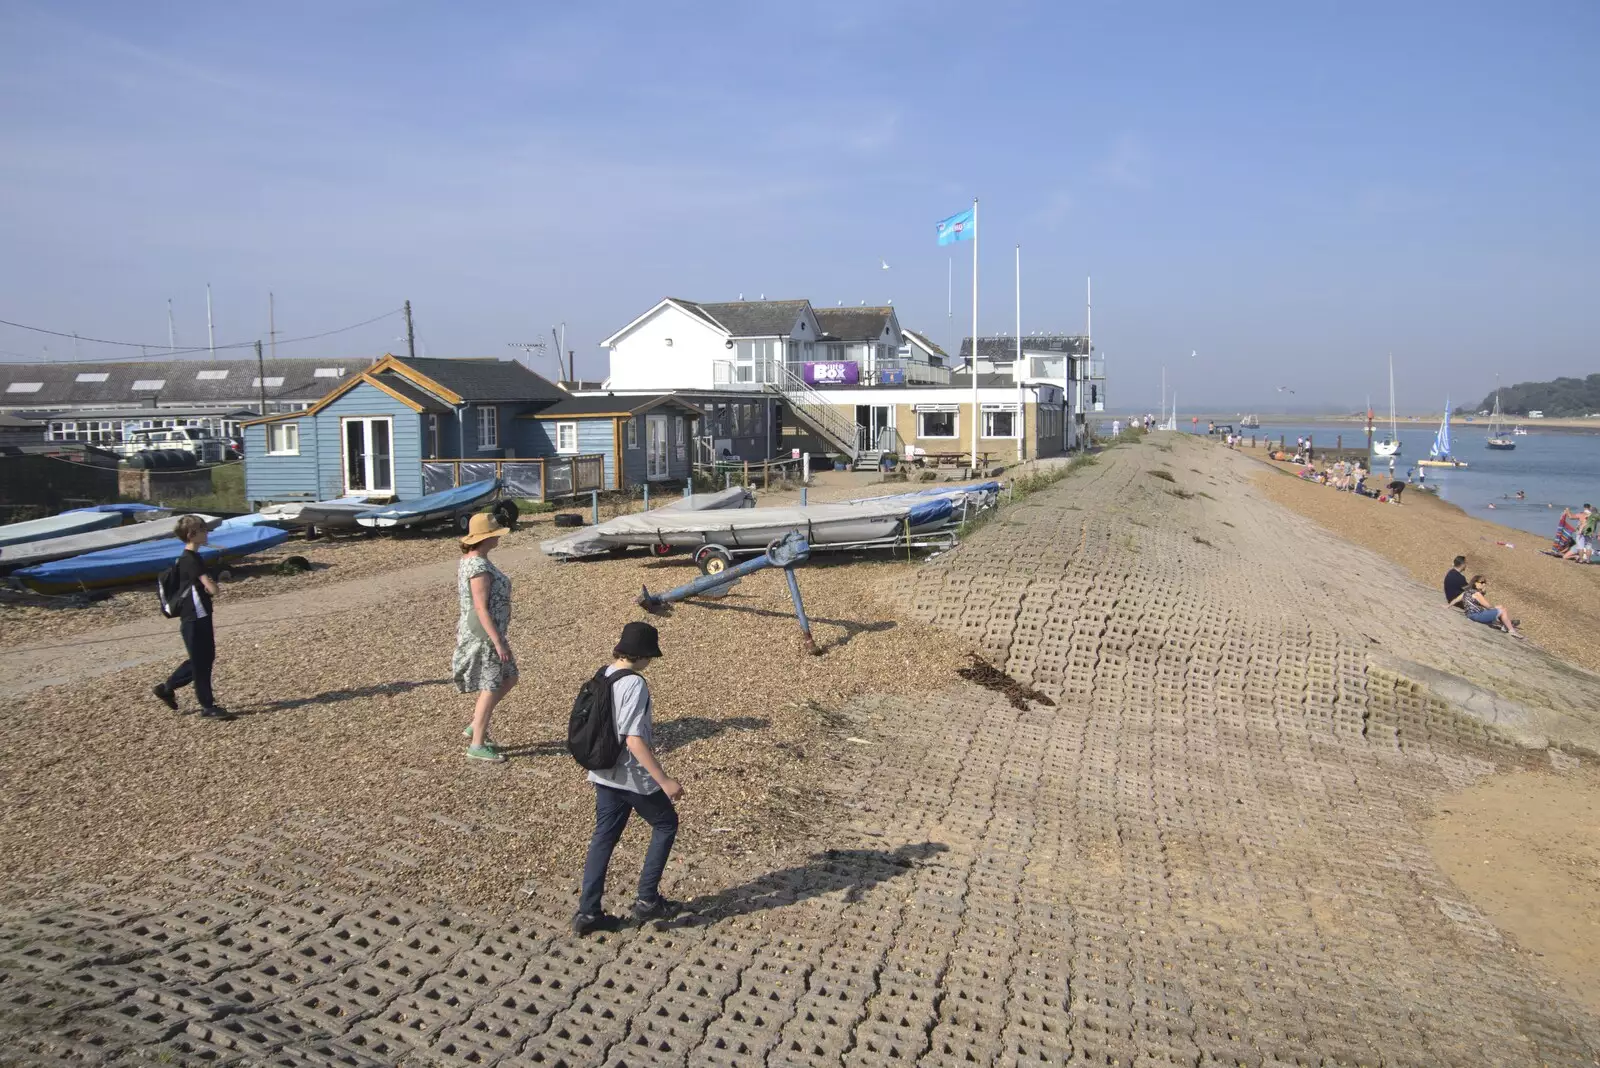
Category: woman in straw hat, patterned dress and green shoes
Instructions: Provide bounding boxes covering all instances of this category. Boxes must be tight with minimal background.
[450,512,517,763]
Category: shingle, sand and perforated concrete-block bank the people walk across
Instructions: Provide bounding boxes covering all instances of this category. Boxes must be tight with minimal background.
[0,433,1600,1068]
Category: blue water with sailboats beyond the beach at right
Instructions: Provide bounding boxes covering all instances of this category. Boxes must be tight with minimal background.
[1182,419,1600,534]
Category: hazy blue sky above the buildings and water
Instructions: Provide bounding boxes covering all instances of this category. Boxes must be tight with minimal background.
[0,0,1600,411]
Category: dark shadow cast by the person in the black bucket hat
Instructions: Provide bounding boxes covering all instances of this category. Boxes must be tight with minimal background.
[672,843,949,926]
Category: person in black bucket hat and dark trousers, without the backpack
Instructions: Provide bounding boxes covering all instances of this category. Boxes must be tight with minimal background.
[573,624,683,935]
